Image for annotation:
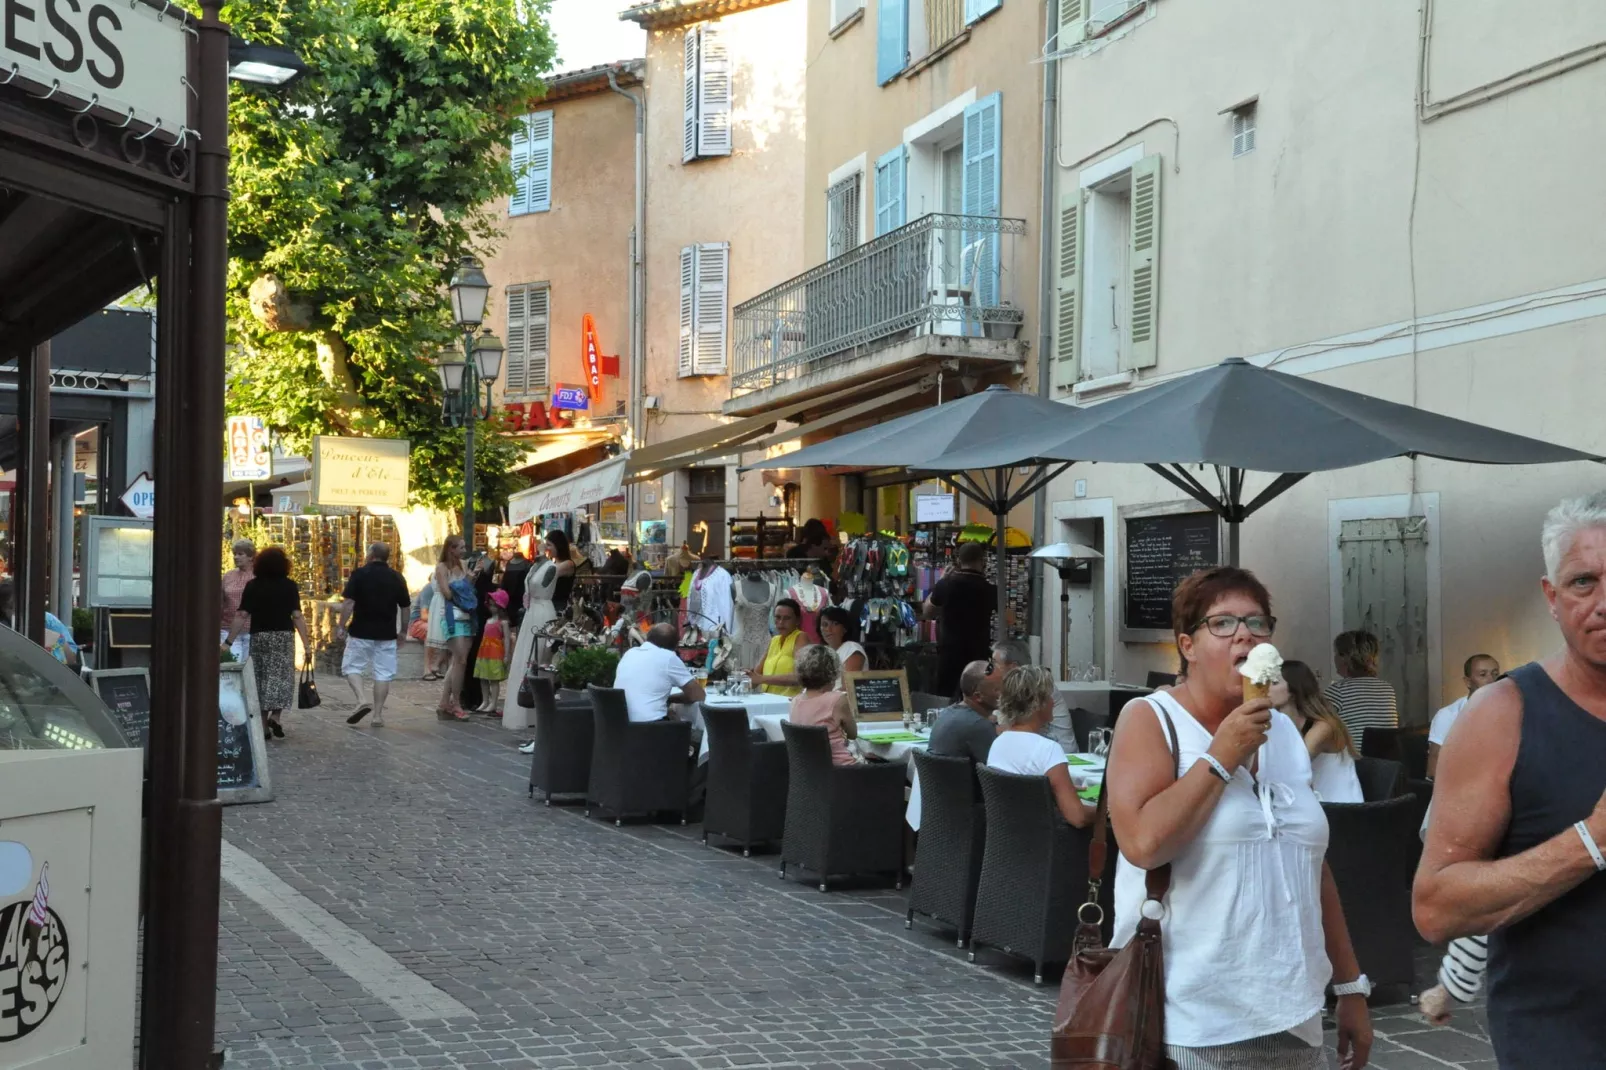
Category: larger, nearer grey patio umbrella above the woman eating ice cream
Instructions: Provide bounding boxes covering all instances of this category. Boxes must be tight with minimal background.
[948,358,1606,564]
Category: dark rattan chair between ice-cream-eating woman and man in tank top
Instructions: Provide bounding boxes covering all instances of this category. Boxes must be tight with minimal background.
[1322,795,1421,985]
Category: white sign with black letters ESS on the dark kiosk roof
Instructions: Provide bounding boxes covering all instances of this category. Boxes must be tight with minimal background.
[0,0,190,140]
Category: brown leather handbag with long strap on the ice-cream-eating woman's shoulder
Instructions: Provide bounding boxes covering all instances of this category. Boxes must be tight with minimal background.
[1052,710,1180,1070]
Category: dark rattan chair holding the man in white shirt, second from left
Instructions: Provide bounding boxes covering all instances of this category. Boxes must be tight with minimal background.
[586,686,692,824]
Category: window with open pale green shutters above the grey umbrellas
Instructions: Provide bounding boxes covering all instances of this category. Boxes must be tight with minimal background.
[1054,156,1161,389]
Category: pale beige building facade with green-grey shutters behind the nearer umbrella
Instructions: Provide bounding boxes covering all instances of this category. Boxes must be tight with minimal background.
[1042,0,1606,725]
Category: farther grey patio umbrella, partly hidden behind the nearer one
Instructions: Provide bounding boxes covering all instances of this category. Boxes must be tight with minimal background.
[742,386,1087,639]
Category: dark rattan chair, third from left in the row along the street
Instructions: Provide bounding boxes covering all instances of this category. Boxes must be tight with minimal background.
[703,705,787,858]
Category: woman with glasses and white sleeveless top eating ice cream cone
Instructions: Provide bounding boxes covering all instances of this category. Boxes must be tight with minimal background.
[1105,567,1372,1070]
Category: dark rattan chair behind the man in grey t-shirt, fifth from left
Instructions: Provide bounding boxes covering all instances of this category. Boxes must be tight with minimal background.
[904,750,988,948]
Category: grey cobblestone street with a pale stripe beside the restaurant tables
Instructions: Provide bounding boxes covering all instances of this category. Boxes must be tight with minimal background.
[207,654,1494,1070]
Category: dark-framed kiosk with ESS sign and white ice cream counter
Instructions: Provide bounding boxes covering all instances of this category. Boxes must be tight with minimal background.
[0,0,240,1070]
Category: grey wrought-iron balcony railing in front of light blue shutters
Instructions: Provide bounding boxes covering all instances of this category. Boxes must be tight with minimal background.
[731,214,1026,394]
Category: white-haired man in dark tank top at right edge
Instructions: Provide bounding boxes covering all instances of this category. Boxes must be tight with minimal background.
[1413,493,1606,1070]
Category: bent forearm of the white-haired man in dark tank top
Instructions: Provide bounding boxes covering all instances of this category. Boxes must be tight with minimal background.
[1412,821,1601,943]
